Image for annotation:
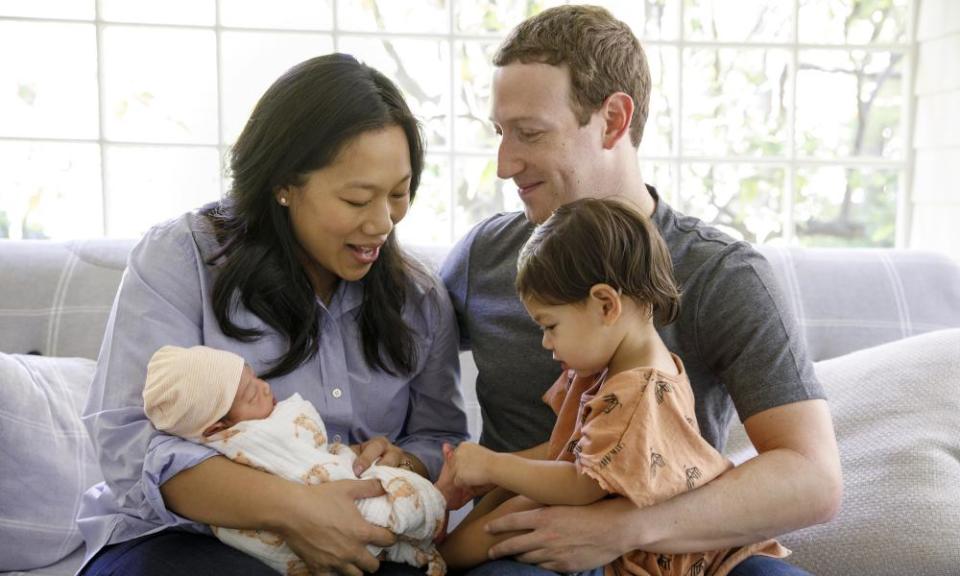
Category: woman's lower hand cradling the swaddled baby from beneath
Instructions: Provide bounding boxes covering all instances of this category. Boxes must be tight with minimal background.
[276,480,396,576]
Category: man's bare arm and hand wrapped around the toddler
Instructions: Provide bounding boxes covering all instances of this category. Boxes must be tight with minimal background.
[489,400,842,572]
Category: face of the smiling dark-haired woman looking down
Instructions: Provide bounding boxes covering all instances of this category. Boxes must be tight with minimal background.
[277,126,411,301]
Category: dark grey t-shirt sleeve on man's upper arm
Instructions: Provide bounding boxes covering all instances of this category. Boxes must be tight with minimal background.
[694,244,825,421]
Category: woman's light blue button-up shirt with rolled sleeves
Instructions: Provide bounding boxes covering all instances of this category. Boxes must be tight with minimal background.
[78,213,467,562]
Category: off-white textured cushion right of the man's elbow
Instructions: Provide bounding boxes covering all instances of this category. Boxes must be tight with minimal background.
[730,330,960,575]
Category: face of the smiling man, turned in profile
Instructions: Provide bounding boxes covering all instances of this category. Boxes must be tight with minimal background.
[492,62,604,224]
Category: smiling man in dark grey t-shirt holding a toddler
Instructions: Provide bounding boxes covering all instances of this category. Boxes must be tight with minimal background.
[442,6,842,574]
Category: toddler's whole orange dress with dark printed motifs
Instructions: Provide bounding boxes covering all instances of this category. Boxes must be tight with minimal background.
[543,355,790,576]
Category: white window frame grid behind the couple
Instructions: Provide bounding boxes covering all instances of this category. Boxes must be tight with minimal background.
[0,0,919,247]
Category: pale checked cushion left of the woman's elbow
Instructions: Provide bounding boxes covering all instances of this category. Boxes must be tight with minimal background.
[0,353,102,572]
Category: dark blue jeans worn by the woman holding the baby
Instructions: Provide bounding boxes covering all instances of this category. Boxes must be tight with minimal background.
[81,530,423,576]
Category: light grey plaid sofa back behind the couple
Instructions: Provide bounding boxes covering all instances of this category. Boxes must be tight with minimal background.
[0,239,960,364]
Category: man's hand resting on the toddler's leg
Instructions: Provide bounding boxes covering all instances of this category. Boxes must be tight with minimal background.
[487,498,639,572]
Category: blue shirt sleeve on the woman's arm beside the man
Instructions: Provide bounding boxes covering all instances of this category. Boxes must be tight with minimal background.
[397,286,468,480]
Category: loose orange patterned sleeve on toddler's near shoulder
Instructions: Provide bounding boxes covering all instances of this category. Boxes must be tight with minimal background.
[575,376,732,507]
